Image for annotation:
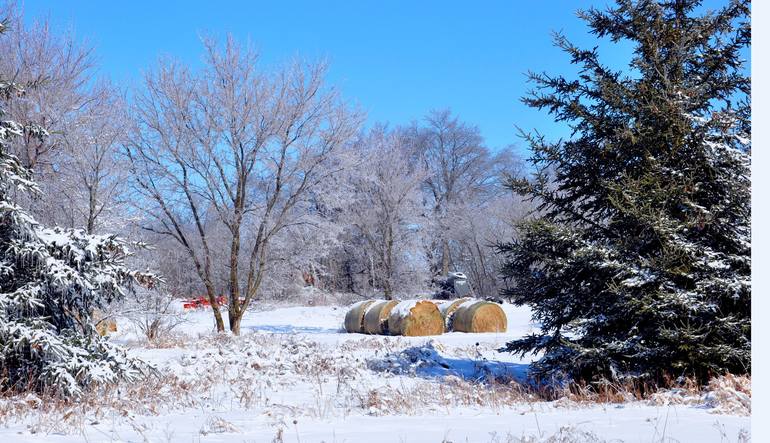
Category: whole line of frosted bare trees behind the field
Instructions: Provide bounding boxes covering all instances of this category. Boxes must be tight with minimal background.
[0,9,527,327]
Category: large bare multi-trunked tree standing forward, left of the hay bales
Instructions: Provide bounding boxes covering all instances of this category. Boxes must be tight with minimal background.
[127,38,361,334]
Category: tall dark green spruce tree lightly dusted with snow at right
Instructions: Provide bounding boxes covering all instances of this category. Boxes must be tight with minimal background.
[500,0,751,383]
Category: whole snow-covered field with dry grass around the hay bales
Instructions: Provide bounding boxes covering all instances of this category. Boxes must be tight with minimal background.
[0,305,750,443]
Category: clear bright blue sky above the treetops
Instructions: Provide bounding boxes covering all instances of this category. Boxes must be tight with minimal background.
[16,0,719,156]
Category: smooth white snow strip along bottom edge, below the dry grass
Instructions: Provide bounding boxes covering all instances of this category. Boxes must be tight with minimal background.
[27,407,740,443]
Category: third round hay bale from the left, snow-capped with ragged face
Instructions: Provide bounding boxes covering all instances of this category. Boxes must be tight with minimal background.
[388,300,444,337]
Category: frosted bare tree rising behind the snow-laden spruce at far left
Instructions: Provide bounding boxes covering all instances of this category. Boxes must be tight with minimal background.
[0,3,131,233]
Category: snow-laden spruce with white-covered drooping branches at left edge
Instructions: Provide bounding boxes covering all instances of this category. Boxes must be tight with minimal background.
[0,19,152,396]
